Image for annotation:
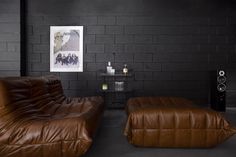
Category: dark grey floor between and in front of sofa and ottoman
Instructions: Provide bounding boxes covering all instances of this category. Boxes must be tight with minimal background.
[84,108,236,157]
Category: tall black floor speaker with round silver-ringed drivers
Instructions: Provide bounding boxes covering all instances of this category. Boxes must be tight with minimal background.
[210,70,227,112]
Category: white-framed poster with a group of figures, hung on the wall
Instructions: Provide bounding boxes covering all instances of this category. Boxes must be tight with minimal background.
[50,26,83,72]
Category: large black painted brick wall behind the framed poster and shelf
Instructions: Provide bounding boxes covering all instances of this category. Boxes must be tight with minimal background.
[27,0,236,103]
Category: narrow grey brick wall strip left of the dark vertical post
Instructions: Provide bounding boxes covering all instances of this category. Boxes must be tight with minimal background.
[0,0,20,77]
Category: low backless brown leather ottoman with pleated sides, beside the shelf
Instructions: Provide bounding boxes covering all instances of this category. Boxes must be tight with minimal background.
[124,97,236,148]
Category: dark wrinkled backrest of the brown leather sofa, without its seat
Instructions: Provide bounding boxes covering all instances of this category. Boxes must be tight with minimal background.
[0,76,66,134]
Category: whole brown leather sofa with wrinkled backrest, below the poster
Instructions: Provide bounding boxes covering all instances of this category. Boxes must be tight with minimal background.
[0,76,103,157]
